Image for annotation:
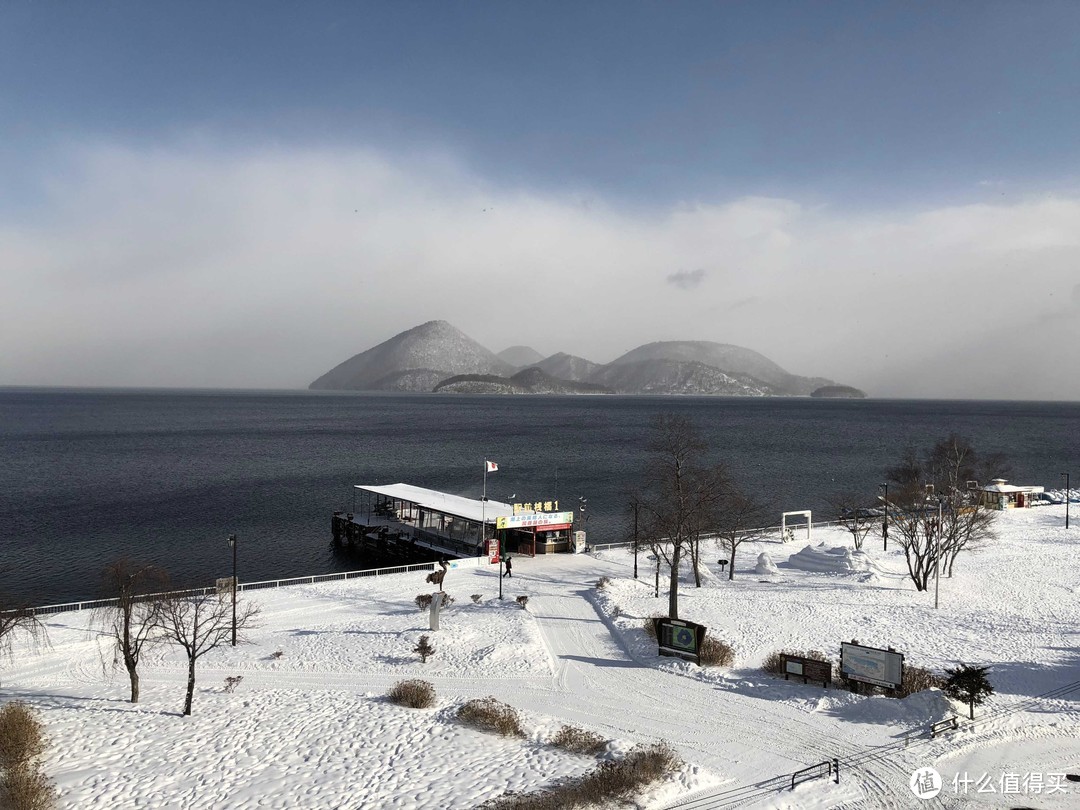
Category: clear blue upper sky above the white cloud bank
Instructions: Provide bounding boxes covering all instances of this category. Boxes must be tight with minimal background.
[8,2,1080,205]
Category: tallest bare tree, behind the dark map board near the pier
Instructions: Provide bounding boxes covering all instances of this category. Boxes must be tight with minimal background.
[640,414,727,619]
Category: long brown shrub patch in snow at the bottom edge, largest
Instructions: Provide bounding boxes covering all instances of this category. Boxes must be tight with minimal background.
[481,742,683,810]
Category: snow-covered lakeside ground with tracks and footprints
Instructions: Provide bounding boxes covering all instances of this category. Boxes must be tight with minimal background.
[0,505,1080,810]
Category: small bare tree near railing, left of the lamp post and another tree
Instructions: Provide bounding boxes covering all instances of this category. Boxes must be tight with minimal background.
[100,559,168,703]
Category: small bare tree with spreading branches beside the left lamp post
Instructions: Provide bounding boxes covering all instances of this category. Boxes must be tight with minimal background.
[161,591,259,715]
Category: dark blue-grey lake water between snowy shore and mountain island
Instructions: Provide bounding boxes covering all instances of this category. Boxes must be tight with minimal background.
[0,389,1080,604]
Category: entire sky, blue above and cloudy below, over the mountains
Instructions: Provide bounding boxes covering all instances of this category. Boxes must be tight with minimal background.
[0,0,1080,401]
